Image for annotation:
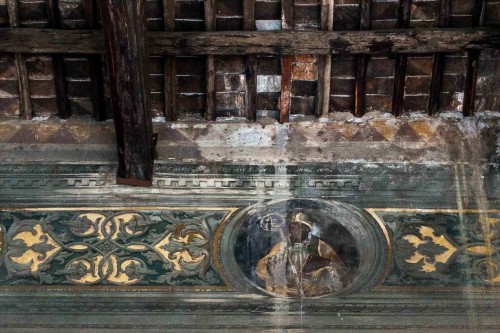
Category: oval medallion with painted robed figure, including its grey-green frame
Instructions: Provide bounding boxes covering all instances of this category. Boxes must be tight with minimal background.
[222,199,390,298]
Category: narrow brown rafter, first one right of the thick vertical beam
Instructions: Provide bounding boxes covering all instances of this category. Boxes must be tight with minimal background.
[163,0,177,121]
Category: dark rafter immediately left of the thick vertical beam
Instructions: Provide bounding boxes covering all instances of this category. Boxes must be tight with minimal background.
[83,0,107,121]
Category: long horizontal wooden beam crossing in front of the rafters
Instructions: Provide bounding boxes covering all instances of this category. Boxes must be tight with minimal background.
[0,28,500,55]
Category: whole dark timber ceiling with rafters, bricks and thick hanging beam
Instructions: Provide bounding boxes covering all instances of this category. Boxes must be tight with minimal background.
[0,0,500,184]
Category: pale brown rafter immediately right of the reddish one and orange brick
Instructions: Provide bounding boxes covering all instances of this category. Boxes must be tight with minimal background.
[316,0,335,118]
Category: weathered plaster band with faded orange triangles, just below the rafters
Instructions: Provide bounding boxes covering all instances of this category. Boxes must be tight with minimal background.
[0,113,500,164]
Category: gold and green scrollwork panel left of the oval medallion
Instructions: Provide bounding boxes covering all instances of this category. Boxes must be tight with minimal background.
[0,211,230,285]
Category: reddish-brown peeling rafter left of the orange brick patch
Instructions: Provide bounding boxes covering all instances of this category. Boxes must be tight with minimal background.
[280,0,293,123]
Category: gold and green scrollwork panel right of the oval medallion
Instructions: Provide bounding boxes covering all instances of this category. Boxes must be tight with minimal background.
[384,213,500,285]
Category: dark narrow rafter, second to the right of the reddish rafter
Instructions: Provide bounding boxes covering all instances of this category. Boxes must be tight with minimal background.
[354,0,370,117]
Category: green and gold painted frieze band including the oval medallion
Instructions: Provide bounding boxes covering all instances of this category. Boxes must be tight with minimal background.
[0,204,500,299]
